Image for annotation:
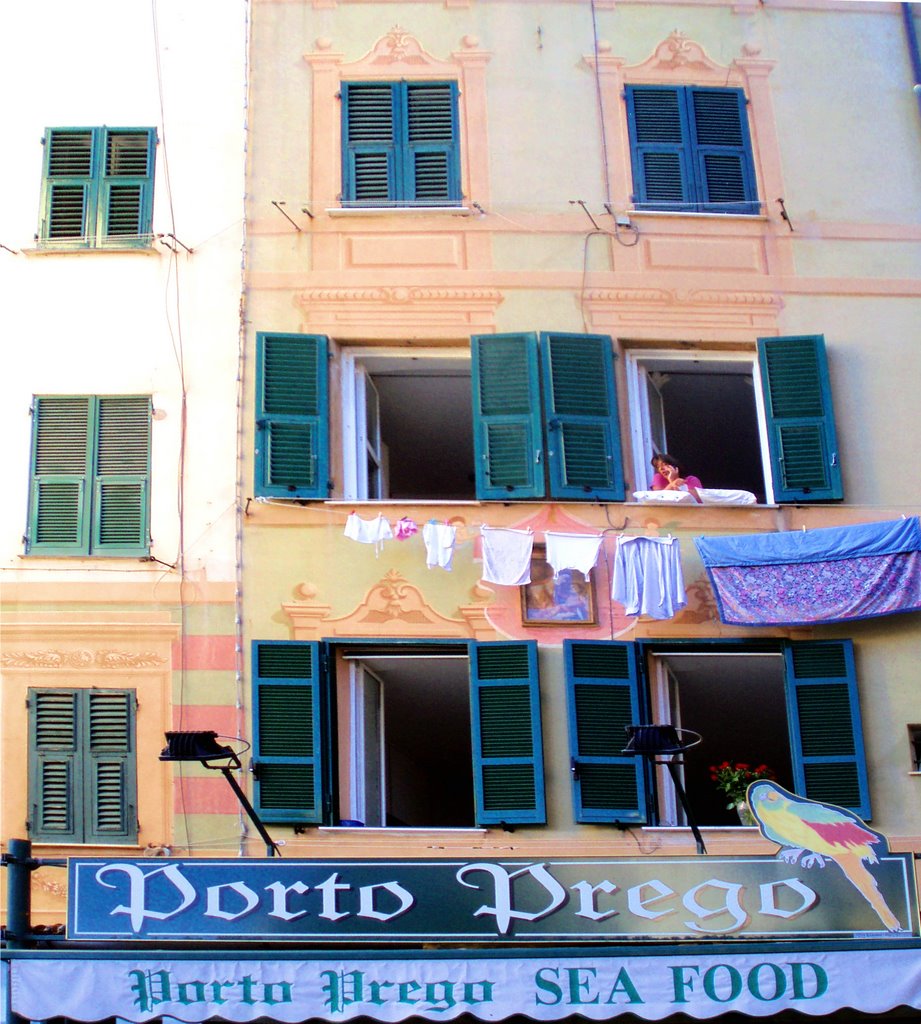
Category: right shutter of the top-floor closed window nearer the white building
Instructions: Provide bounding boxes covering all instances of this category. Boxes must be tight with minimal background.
[404,82,461,206]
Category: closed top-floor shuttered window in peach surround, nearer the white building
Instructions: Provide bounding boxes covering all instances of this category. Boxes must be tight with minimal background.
[341,82,461,207]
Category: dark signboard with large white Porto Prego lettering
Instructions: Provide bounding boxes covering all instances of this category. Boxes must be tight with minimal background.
[68,853,921,943]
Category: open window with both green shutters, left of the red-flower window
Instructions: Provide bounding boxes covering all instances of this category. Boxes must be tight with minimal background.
[253,641,545,828]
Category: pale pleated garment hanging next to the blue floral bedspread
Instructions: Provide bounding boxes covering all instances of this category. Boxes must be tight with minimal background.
[611,537,687,618]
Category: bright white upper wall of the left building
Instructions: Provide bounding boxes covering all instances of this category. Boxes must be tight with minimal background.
[0,0,247,581]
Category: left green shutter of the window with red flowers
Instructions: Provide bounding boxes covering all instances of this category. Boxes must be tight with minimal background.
[563,640,646,822]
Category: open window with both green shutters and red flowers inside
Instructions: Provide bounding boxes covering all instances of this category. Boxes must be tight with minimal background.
[563,640,870,825]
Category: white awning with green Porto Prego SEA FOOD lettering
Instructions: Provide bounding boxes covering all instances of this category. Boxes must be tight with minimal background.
[4,943,921,1022]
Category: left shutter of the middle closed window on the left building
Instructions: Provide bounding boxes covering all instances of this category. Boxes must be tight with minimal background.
[26,396,94,555]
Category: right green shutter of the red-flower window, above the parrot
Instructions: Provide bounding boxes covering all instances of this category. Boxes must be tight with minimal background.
[784,640,870,821]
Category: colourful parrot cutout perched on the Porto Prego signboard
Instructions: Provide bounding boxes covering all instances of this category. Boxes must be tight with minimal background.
[746,780,903,932]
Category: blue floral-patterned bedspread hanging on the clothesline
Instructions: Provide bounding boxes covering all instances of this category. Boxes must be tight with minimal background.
[695,516,921,626]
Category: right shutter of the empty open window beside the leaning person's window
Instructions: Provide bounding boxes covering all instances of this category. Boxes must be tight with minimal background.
[470,334,544,501]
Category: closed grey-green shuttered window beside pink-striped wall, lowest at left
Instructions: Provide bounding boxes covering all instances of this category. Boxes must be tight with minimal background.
[29,689,137,844]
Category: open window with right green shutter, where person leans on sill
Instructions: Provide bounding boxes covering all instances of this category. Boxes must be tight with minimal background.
[626,336,843,503]
